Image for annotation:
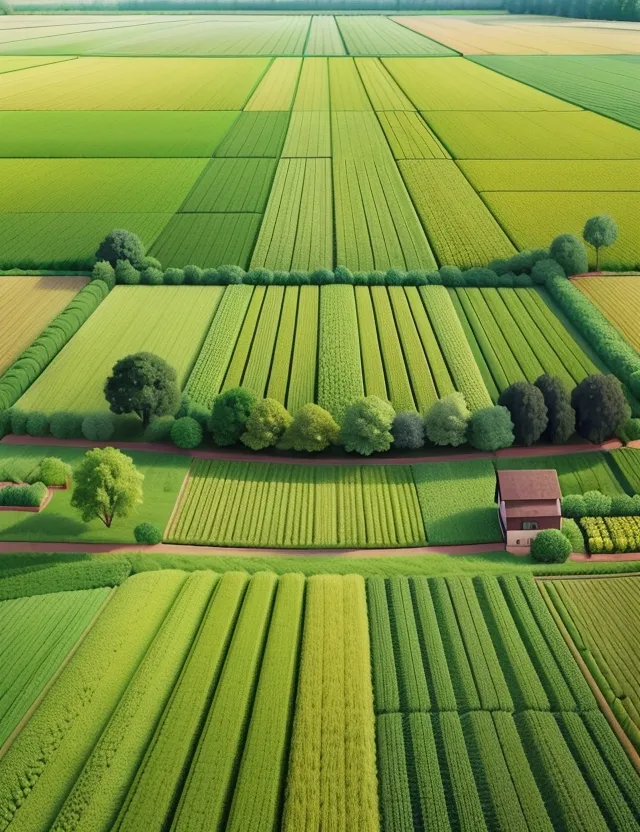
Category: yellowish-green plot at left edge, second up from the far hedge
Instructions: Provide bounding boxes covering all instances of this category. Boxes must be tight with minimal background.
[0,159,206,213]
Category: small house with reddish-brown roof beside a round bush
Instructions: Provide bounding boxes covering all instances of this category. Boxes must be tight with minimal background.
[496,468,562,552]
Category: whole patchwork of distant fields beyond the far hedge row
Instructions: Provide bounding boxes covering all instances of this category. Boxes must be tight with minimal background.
[0,15,640,271]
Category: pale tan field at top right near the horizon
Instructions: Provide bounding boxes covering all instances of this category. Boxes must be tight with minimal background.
[394,15,640,55]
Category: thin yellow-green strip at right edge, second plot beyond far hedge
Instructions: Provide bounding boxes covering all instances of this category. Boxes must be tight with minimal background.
[458,159,640,192]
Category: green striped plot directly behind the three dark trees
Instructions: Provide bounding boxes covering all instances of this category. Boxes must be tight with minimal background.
[452,289,599,391]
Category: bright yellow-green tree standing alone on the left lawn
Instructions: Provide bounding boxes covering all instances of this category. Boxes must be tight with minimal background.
[71,448,144,528]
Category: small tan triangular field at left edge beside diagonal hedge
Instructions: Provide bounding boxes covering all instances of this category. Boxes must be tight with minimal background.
[0,277,88,373]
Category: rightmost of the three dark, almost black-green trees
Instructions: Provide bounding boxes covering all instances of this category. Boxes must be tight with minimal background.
[571,375,631,444]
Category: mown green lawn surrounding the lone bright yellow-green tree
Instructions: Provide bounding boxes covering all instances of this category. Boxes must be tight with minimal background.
[0,445,190,544]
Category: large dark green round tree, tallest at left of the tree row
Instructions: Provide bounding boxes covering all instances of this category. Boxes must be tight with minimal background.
[104,352,180,428]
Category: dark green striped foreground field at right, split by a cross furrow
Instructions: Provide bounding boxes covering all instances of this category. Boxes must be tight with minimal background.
[367,577,639,830]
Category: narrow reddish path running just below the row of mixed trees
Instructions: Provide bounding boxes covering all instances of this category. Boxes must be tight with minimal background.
[0,434,624,465]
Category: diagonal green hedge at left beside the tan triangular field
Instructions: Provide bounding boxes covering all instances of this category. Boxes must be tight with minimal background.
[0,281,109,410]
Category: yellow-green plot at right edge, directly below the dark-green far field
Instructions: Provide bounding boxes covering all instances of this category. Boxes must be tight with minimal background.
[424,111,640,161]
